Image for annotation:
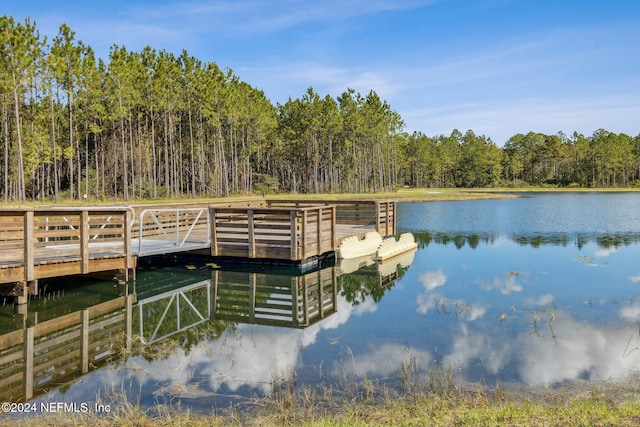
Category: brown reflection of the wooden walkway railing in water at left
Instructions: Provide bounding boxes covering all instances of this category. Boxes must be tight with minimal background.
[0,295,134,402]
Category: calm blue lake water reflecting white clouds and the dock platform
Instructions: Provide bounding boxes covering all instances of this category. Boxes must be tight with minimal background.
[0,193,640,412]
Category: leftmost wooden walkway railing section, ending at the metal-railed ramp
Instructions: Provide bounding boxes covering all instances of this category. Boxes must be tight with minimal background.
[0,207,131,283]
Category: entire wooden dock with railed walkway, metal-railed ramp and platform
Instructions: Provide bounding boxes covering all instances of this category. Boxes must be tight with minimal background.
[0,199,396,302]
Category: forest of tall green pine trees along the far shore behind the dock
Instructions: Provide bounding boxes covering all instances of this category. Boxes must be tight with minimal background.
[0,15,640,202]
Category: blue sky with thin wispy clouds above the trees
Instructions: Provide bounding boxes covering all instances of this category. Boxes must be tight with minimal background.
[5,0,640,145]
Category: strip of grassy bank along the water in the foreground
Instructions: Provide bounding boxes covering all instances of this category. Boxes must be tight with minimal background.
[5,373,640,427]
